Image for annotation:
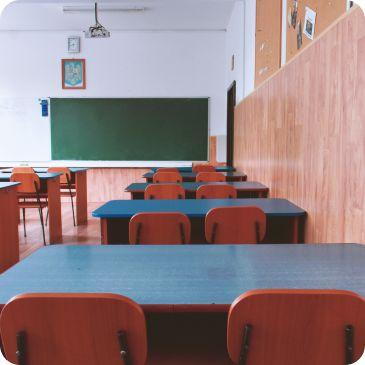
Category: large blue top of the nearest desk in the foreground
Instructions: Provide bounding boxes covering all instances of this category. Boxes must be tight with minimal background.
[0,244,365,305]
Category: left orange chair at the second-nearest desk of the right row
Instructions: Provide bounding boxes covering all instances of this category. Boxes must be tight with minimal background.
[129,212,190,245]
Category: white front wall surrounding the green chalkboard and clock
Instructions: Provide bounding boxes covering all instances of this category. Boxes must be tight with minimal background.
[0,31,226,161]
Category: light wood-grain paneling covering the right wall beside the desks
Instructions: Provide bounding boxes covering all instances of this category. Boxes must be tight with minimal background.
[234,7,365,243]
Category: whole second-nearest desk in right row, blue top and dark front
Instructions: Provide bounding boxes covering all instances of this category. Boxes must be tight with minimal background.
[92,199,306,244]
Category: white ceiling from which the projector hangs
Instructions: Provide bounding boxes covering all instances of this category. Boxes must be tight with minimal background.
[0,0,240,31]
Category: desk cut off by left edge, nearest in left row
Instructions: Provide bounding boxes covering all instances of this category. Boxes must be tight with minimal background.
[0,182,19,273]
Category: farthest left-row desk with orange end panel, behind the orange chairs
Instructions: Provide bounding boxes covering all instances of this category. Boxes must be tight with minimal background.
[1,167,88,226]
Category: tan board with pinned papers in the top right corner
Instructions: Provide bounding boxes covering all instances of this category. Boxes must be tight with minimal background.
[286,0,347,61]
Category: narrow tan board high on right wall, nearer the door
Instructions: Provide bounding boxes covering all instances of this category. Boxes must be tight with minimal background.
[255,0,282,86]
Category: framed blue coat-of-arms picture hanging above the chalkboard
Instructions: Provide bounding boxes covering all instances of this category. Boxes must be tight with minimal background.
[62,58,86,89]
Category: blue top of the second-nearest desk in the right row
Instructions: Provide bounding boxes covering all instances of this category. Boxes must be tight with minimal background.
[92,199,306,218]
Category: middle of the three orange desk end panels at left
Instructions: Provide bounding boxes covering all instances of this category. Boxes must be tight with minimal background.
[47,177,62,244]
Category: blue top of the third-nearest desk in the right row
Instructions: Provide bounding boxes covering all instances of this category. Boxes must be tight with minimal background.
[125,181,269,192]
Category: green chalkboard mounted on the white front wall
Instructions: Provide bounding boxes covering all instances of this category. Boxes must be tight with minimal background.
[51,98,209,161]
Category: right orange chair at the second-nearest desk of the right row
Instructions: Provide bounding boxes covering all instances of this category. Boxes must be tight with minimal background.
[205,207,266,244]
